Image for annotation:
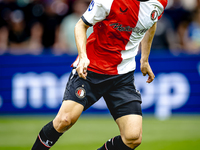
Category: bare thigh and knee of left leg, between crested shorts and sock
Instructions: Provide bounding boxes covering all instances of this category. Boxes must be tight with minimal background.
[53,100,84,132]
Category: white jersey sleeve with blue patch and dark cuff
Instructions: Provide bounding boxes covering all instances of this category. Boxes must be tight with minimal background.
[81,0,112,26]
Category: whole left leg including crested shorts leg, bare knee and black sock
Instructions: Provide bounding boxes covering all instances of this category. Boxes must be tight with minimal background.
[32,69,96,150]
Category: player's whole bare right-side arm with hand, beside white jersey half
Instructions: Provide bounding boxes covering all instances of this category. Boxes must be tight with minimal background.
[140,23,157,83]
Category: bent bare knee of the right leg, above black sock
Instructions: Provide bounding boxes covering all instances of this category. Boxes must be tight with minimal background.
[123,133,142,147]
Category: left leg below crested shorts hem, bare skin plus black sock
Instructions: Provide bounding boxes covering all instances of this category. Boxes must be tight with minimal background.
[32,100,84,150]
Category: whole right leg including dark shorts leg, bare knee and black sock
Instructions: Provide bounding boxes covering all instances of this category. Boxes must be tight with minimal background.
[98,72,142,150]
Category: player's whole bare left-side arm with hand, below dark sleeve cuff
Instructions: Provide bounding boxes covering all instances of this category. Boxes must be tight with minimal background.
[74,19,90,79]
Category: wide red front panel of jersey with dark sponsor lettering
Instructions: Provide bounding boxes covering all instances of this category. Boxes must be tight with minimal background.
[86,0,140,75]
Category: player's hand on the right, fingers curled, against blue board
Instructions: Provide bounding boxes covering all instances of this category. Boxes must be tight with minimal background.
[140,62,155,83]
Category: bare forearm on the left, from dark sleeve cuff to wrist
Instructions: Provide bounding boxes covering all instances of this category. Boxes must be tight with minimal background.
[74,19,88,59]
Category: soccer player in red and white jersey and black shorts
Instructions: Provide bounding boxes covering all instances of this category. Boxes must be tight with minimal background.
[32,0,167,150]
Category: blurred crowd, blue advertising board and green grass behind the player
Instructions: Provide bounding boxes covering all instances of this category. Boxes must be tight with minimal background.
[0,0,200,150]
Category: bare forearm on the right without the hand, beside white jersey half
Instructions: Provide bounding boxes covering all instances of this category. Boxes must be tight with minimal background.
[140,23,157,63]
